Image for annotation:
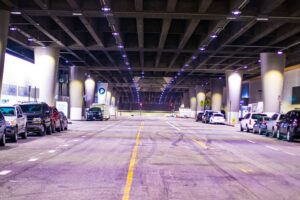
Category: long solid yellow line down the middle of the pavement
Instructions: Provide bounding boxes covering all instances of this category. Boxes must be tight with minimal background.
[122,122,144,200]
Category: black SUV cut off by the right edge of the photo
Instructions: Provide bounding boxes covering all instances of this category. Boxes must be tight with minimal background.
[277,110,300,142]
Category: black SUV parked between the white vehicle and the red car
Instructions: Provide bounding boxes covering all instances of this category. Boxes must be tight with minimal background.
[20,102,51,136]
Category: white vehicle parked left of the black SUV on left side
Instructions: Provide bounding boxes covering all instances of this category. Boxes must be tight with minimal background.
[0,105,27,142]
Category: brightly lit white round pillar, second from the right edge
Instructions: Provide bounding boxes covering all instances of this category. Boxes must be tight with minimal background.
[226,71,243,123]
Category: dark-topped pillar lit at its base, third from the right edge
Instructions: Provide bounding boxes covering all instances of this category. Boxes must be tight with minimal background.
[210,79,224,111]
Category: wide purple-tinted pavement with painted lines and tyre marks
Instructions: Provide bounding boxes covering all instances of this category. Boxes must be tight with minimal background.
[0,116,300,199]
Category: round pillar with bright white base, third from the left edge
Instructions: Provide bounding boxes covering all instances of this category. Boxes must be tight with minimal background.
[69,66,84,120]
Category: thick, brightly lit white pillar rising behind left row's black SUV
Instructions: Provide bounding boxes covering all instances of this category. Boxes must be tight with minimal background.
[34,47,59,106]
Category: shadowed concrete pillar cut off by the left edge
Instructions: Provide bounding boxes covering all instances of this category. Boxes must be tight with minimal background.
[0,10,10,95]
